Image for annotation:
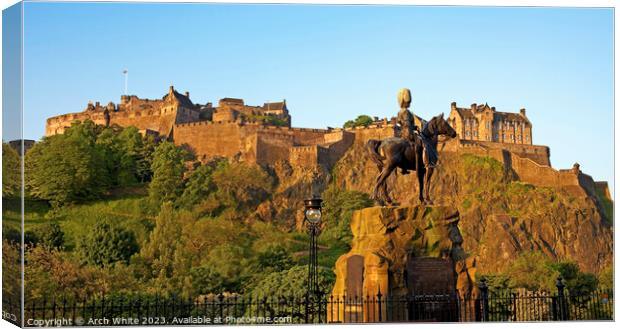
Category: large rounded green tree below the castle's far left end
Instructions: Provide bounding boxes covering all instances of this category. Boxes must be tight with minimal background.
[25,121,109,206]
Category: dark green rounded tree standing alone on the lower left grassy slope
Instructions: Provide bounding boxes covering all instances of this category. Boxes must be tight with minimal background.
[78,222,139,266]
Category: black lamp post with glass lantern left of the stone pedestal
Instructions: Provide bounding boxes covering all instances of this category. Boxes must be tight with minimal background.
[304,196,323,322]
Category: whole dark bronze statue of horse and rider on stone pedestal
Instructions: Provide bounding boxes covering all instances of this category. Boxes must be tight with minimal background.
[366,88,456,205]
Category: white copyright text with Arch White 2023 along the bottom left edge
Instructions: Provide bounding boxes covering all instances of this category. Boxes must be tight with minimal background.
[25,316,293,327]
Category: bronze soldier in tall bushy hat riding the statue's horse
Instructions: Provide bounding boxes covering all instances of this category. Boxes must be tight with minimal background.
[397,88,437,175]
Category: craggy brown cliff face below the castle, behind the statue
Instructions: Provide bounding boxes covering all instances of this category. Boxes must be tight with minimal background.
[326,145,613,273]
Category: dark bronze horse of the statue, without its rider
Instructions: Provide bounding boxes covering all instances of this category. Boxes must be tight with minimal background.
[366,113,456,205]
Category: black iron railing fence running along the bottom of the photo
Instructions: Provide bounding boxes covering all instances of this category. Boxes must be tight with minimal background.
[3,287,614,326]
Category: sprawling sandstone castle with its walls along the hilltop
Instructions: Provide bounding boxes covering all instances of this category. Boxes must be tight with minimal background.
[45,86,606,199]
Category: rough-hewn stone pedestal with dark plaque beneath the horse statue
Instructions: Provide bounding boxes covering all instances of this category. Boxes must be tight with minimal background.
[328,206,475,322]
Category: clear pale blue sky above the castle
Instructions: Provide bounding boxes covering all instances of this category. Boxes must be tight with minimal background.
[19,3,614,192]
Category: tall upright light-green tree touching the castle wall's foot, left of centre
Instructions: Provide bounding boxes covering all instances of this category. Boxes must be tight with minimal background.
[149,142,188,206]
